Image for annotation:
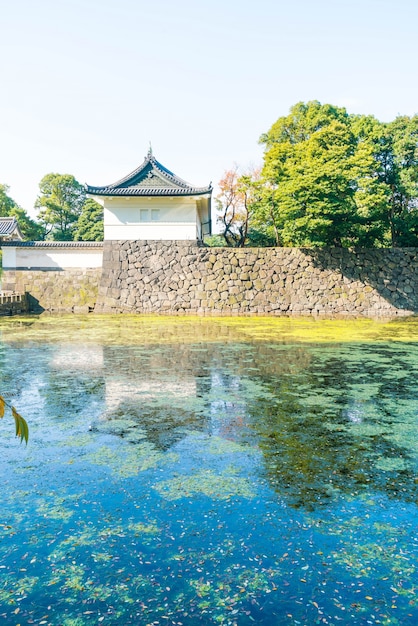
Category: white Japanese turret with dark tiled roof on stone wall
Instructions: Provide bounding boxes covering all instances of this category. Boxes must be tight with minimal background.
[86,149,212,241]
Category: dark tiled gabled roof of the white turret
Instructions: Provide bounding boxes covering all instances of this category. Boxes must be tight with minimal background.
[86,150,212,196]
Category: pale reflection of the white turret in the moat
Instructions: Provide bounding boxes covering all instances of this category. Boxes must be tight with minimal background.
[94,344,219,450]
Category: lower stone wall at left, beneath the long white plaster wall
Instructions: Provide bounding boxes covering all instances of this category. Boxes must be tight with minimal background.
[2,268,102,313]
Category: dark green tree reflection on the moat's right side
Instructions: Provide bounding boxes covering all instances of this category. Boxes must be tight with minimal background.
[248,346,416,507]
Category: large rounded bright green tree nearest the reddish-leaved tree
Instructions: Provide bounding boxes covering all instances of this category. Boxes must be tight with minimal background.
[257,101,374,246]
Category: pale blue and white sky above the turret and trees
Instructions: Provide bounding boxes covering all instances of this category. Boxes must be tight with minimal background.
[0,0,418,216]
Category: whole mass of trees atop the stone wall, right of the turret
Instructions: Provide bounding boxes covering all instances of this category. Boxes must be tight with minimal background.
[218,101,418,247]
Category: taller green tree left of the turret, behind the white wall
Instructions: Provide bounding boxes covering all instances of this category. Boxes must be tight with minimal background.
[35,174,86,241]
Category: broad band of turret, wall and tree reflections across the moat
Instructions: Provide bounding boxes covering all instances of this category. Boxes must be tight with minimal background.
[3,322,418,509]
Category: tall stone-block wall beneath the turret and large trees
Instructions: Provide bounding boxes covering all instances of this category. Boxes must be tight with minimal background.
[95,241,418,317]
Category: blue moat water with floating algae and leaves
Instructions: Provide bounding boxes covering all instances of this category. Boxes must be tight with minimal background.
[0,316,418,626]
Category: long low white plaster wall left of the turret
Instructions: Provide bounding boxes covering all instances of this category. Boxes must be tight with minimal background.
[3,246,103,269]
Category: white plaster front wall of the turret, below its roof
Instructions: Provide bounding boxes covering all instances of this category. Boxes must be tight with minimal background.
[104,197,198,240]
